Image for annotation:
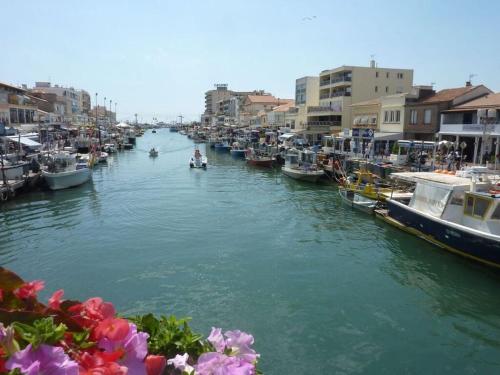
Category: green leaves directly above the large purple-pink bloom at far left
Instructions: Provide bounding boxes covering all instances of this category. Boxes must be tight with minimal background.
[13,317,67,348]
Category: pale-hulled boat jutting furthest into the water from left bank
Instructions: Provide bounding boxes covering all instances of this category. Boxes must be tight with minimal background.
[42,153,92,190]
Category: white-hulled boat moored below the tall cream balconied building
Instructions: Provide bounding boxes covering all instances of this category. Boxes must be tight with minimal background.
[281,150,325,182]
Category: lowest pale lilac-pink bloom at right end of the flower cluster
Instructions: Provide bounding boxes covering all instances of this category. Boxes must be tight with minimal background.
[194,352,255,375]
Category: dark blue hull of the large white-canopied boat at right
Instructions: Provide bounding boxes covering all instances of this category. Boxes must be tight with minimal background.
[386,199,500,267]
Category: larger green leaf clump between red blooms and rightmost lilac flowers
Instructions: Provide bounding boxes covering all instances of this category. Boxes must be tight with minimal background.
[129,314,213,360]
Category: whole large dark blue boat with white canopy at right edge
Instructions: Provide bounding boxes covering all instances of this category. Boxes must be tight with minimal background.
[376,172,500,267]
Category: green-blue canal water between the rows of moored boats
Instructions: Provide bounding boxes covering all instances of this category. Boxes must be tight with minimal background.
[0,129,500,374]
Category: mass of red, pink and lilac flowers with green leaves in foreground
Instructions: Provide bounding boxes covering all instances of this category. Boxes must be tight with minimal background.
[0,267,259,375]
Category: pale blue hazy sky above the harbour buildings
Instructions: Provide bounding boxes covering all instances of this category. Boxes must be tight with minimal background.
[0,0,500,122]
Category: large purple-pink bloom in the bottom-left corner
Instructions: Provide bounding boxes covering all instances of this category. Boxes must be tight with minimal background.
[5,344,78,375]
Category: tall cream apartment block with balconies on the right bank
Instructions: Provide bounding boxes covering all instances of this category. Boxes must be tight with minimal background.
[307,61,413,141]
